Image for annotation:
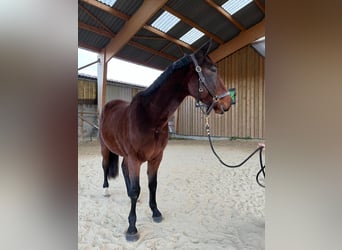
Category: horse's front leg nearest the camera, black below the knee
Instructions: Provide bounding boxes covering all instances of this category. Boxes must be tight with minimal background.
[122,159,141,241]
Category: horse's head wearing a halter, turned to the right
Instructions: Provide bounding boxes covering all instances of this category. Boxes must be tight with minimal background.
[188,40,235,115]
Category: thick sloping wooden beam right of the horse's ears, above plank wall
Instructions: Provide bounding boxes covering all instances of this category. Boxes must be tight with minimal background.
[209,18,265,62]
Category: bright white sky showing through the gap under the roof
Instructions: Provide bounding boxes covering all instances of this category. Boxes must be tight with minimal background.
[78,48,162,87]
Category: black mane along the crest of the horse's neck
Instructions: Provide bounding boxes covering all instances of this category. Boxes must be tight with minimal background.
[140,55,191,96]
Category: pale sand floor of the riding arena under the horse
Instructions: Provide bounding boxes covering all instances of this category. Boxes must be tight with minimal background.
[78,140,265,250]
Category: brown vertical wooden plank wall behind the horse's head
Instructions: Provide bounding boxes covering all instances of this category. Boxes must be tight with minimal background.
[175,46,265,138]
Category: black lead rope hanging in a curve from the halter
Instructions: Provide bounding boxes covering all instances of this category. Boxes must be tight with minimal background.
[205,116,265,188]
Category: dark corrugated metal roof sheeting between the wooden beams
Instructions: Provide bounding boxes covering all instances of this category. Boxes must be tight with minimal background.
[78,0,265,69]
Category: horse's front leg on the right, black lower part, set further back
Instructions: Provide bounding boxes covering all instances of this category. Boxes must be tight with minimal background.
[147,154,163,223]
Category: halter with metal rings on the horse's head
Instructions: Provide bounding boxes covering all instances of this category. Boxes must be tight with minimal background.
[190,54,230,115]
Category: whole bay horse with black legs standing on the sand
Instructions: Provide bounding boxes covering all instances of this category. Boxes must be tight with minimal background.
[99,40,231,241]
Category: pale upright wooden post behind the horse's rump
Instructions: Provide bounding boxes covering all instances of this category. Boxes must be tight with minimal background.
[97,48,108,114]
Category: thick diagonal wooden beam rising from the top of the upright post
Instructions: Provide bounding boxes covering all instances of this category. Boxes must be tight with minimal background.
[106,0,167,62]
